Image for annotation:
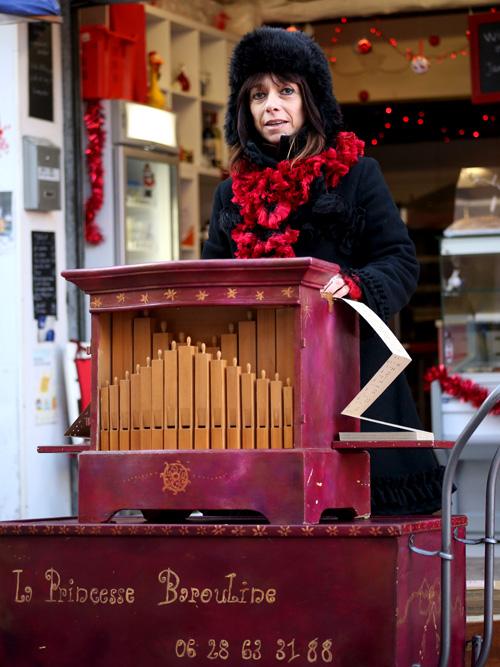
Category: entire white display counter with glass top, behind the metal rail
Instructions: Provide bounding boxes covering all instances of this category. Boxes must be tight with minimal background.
[431,167,500,549]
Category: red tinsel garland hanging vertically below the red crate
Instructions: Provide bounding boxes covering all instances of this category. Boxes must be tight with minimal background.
[83,100,106,245]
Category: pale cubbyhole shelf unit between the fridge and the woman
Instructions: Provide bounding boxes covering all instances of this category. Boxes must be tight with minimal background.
[145,5,239,259]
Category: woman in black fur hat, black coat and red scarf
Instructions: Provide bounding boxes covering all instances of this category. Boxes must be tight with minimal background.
[203,27,442,514]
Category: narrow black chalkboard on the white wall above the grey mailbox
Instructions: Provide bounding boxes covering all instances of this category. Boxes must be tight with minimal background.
[28,23,54,120]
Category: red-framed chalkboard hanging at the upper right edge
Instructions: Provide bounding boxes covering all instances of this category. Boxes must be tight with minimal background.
[469,12,500,104]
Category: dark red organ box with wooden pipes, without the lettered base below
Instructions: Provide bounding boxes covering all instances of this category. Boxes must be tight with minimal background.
[59,258,370,523]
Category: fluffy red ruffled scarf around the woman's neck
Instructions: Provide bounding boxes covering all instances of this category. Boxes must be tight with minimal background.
[231,132,364,259]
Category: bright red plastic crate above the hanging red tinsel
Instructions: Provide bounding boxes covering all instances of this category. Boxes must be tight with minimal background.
[80,25,135,100]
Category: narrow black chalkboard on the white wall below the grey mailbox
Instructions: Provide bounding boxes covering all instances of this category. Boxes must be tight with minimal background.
[31,232,57,319]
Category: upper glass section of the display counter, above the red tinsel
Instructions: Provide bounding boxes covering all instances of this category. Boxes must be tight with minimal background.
[440,168,500,373]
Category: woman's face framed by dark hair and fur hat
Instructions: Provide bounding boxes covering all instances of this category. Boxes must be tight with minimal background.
[250,74,304,144]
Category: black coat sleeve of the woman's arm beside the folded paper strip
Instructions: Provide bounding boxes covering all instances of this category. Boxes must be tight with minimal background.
[350,158,419,321]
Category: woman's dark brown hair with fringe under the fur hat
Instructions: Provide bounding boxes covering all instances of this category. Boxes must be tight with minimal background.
[229,72,326,170]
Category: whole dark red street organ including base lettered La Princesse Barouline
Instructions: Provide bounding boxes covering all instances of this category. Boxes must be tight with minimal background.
[0,258,494,667]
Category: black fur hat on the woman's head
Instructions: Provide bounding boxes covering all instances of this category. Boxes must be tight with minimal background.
[224,27,342,146]
